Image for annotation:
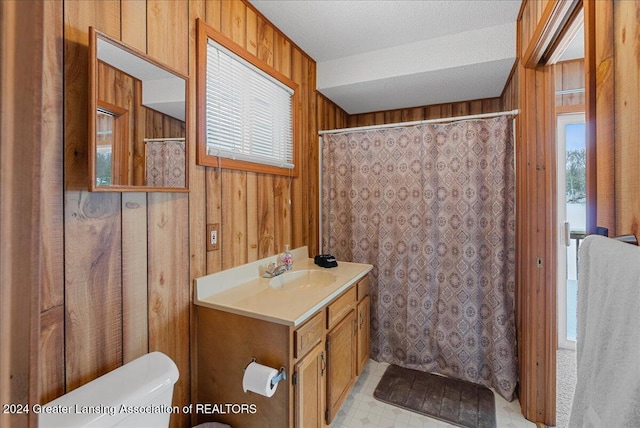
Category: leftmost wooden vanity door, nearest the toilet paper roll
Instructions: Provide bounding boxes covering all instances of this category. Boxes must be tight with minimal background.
[294,343,327,428]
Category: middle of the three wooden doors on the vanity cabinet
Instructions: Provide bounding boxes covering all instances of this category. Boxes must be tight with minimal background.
[327,309,358,424]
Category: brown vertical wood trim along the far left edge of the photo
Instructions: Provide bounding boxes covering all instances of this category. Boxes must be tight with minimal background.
[0,1,53,427]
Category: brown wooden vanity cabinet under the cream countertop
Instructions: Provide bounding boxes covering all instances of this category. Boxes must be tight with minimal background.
[192,276,370,428]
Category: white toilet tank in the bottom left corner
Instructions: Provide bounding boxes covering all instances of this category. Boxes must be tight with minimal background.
[38,352,180,428]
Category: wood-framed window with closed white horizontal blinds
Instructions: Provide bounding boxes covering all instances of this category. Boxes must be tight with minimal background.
[198,21,297,176]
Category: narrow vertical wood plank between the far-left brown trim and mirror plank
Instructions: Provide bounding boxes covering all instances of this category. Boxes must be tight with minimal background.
[38,1,65,404]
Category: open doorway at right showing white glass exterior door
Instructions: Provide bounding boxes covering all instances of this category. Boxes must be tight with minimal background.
[552,13,593,427]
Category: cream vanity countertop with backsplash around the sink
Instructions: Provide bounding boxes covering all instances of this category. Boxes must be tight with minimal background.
[195,247,373,326]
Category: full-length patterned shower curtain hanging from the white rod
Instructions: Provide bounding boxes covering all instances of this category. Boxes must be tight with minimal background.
[322,116,518,400]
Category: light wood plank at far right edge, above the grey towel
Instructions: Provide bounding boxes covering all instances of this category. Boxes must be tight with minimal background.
[613,2,640,236]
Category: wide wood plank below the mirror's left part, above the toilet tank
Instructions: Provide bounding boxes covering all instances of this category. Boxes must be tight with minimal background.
[65,191,122,390]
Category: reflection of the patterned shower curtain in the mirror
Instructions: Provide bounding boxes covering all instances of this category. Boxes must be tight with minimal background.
[146,139,186,187]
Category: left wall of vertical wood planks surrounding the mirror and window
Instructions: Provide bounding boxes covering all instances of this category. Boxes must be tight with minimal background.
[38,0,324,426]
